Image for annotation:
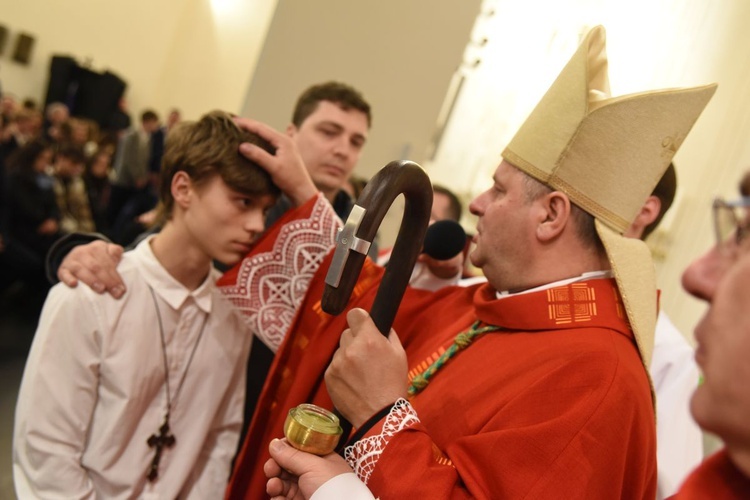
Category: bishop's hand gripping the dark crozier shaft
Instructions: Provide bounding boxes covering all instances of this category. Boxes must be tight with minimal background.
[325,309,407,427]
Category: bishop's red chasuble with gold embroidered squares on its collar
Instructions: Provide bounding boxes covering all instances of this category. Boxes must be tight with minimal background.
[222,194,656,499]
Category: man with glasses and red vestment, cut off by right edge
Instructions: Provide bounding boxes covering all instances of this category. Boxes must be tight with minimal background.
[677,180,750,498]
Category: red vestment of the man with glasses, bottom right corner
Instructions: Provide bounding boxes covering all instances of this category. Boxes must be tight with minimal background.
[670,450,750,500]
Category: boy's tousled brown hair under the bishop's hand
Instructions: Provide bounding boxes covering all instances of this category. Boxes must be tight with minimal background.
[159,111,280,220]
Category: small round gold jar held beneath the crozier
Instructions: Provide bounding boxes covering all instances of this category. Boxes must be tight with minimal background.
[284,403,342,455]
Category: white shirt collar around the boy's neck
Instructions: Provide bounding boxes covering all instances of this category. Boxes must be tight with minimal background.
[132,234,216,314]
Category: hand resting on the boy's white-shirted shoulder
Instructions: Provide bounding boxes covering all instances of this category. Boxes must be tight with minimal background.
[57,241,125,299]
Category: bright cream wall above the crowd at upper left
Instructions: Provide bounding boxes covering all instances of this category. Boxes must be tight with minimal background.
[0,0,276,118]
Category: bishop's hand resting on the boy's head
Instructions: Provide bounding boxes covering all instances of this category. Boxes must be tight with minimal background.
[234,117,318,206]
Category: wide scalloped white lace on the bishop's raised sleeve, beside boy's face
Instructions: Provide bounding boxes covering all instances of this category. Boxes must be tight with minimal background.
[221,194,342,352]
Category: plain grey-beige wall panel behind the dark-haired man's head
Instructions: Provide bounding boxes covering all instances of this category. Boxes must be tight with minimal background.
[242,0,480,246]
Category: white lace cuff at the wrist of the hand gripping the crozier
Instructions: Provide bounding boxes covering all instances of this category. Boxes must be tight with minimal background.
[344,398,419,484]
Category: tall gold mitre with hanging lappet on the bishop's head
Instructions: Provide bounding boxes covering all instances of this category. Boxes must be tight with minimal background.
[502,26,716,366]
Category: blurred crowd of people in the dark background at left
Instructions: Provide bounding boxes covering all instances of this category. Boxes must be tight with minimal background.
[0,94,180,313]
